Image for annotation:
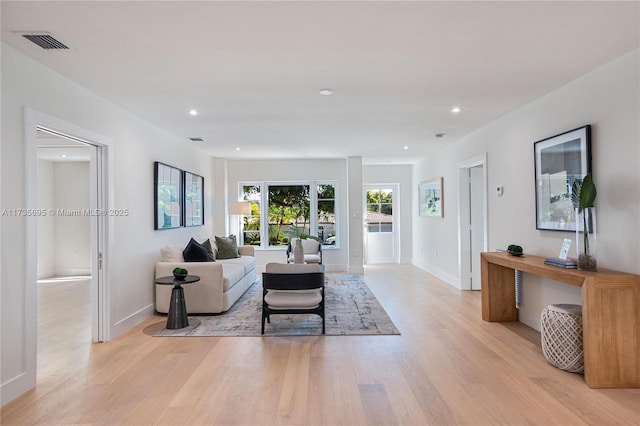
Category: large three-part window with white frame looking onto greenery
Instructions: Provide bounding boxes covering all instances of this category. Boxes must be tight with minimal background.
[240,182,336,247]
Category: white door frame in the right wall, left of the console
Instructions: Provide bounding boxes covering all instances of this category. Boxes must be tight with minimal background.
[458,152,489,290]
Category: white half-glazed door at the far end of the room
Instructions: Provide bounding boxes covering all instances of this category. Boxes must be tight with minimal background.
[363,184,399,264]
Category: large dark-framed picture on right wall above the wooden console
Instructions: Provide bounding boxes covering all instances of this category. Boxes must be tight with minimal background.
[533,125,591,231]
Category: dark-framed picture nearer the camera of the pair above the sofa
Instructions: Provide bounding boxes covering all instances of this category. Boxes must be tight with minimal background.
[153,161,183,229]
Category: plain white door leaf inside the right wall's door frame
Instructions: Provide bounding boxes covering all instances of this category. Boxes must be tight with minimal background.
[468,165,484,290]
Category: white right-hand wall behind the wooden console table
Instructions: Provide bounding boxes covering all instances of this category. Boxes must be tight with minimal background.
[413,50,640,329]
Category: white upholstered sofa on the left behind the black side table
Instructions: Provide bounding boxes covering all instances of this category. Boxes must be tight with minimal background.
[155,246,256,314]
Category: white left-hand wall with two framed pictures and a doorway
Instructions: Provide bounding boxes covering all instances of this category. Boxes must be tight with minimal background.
[0,44,212,404]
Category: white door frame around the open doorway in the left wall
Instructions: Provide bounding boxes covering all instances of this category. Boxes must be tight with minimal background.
[24,107,114,387]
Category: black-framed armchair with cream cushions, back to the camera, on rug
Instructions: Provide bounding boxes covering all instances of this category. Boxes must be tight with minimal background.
[261,263,325,334]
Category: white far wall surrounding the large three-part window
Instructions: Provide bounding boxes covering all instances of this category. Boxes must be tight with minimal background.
[227,159,349,271]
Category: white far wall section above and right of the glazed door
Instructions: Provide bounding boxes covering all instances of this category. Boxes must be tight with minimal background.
[362,165,418,263]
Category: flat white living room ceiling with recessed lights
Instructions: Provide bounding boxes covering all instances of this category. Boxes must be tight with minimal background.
[0,0,640,164]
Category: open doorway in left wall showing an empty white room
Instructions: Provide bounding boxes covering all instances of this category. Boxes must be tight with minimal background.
[37,128,95,368]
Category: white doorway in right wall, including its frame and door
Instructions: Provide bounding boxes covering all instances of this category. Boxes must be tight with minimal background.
[458,154,488,290]
